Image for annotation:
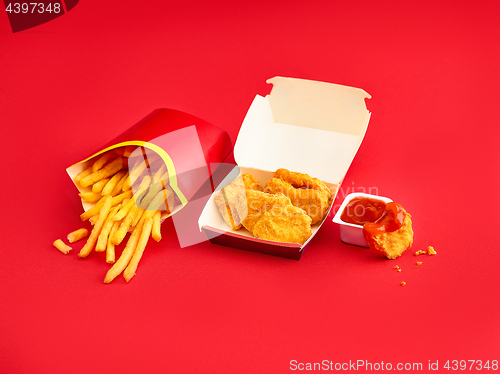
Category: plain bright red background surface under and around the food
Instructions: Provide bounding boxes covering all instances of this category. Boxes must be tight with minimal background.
[0,0,500,374]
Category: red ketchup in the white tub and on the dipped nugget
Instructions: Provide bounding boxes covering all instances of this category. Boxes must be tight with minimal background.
[340,197,406,236]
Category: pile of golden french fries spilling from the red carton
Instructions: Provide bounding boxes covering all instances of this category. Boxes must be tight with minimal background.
[54,146,178,283]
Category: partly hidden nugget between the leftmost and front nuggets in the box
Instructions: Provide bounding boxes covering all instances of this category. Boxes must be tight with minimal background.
[238,190,292,234]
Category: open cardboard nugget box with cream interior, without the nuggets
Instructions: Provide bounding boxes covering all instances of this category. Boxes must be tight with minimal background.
[198,77,371,260]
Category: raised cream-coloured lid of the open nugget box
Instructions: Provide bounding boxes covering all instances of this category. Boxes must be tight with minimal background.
[234,77,371,183]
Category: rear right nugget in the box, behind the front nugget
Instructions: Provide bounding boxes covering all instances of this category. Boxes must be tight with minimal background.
[264,178,329,225]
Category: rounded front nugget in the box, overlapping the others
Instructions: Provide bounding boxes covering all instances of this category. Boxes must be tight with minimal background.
[253,205,312,244]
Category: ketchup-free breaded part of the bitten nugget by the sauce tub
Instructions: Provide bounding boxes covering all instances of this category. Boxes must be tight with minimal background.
[363,207,413,260]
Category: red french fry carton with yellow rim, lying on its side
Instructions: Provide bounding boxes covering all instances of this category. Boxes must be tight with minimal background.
[67,109,232,219]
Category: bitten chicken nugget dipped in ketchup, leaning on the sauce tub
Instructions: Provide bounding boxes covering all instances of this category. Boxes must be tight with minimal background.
[363,203,413,260]
